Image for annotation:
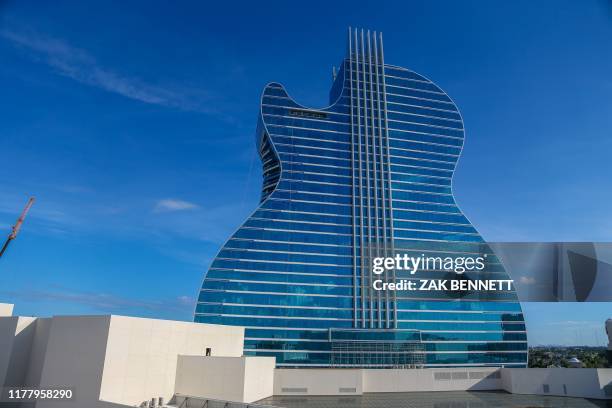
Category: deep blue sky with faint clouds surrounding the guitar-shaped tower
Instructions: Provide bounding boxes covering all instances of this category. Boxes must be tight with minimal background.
[0,0,612,344]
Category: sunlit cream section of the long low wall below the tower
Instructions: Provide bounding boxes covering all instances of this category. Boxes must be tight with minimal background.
[274,367,502,395]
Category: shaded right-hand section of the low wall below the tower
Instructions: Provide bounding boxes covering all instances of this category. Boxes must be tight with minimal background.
[501,368,612,399]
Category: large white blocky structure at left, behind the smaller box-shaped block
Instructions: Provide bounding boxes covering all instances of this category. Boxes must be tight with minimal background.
[0,315,246,408]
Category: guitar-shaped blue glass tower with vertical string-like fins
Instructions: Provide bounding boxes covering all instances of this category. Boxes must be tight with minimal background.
[195,30,527,367]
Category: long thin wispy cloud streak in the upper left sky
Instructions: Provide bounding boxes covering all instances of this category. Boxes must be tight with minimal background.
[0,29,213,113]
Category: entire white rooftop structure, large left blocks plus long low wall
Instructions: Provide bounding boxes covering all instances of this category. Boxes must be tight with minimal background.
[0,308,612,408]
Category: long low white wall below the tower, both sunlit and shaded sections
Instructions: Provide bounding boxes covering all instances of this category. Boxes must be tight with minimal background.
[274,367,612,399]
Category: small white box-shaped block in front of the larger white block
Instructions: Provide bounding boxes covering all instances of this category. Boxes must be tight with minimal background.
[175,356,276,403]
